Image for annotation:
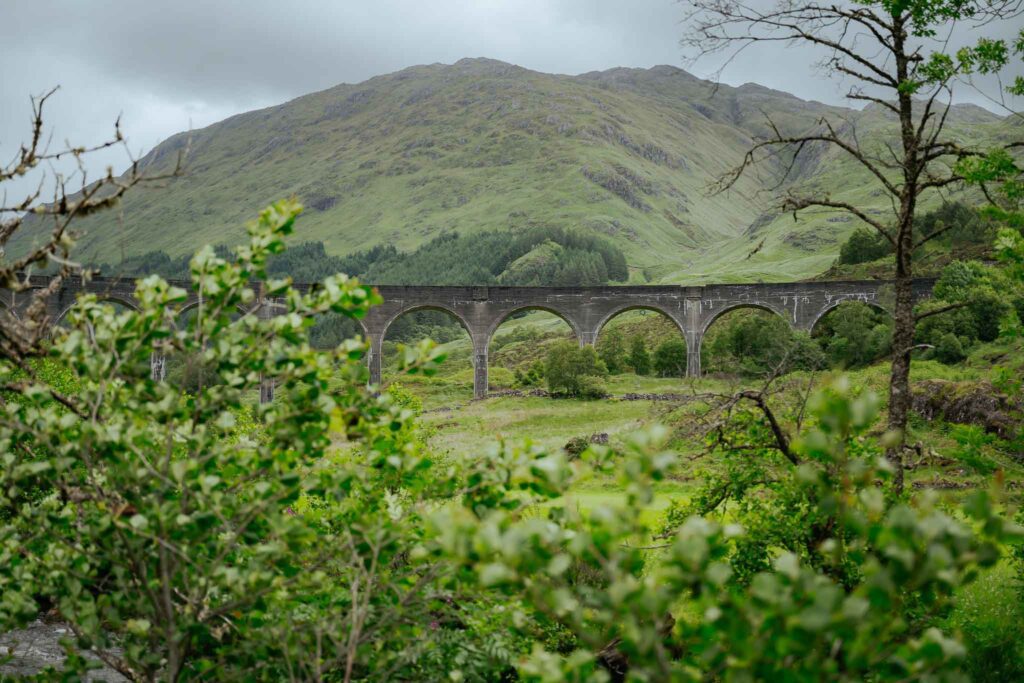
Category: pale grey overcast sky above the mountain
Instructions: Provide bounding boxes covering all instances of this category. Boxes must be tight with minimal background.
[0,0,1013,202]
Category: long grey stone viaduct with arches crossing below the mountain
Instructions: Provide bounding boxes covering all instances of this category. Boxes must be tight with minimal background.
[0,276,935,401]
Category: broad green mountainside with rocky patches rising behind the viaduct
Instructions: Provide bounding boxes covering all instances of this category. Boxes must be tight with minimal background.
[14,59,1008,283]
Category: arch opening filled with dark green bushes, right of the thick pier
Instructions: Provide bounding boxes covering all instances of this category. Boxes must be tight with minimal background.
[697,304,823,378]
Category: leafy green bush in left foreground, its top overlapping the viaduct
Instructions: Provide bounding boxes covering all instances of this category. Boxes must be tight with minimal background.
[0,202,491,680]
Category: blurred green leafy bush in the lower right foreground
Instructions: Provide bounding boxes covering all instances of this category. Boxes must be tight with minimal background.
[432,384,1020,681]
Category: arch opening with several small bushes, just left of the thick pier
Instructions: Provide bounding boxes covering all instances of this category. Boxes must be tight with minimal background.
[596,306,692,382]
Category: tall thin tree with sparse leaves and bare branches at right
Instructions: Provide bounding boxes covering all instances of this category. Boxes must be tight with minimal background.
[682,0,1024,489]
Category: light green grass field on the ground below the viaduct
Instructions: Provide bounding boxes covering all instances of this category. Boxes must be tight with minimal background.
[374,329,1024,529]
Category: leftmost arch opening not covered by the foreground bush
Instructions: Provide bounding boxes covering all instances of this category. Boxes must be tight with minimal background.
[379,306,476,401]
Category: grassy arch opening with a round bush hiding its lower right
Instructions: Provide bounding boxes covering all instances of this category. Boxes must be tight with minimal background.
[487,306,580,390]
